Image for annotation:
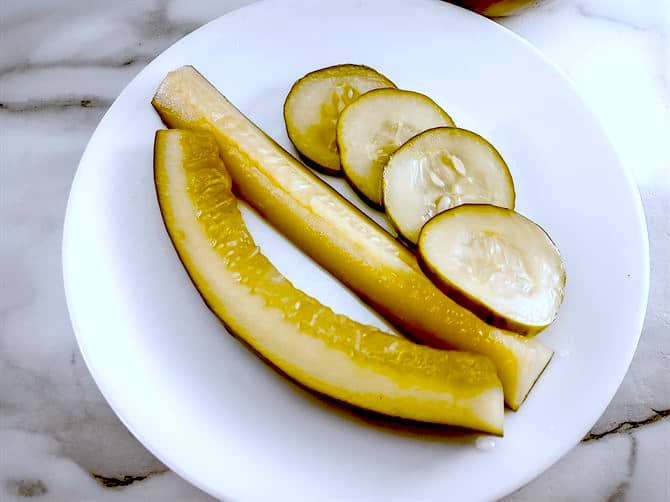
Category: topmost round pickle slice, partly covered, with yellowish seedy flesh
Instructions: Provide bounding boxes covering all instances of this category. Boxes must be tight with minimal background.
[284,64,395,174]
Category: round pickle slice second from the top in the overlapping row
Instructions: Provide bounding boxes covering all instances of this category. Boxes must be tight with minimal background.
[337,89,454,209]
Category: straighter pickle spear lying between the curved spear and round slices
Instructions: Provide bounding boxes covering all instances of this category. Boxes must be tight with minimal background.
[152,66,553,409]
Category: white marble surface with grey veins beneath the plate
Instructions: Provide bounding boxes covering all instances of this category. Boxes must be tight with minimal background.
[0,0,670,502]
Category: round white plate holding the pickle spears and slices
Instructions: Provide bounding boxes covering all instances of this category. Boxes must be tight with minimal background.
[63,0,649,502]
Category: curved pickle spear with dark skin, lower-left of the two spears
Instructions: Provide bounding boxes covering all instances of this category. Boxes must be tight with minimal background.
[154,130,504,434]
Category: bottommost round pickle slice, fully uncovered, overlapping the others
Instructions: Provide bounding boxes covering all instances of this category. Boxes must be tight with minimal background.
[419,204,565,335]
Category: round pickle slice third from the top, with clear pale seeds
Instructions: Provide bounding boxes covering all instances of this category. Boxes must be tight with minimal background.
[383,127,515,244]
